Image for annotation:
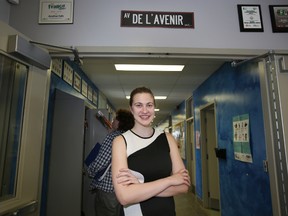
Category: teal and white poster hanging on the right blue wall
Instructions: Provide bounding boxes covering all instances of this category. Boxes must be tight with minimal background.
[233,114,253,163]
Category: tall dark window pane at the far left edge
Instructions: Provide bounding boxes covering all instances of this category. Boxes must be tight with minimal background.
[0,53,28,201]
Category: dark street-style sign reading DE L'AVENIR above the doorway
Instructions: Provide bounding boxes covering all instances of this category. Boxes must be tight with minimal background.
[121,10,194,28]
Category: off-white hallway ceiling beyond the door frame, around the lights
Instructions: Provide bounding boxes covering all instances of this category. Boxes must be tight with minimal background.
[82,57,226,125]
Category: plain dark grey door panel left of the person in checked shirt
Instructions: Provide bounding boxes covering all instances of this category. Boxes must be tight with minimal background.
[46,89,85,216]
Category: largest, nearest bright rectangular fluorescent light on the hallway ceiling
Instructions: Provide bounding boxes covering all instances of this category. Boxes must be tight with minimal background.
[115,64,184,71]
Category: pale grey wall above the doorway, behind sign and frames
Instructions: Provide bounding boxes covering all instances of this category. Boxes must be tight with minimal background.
[0,0,288,55]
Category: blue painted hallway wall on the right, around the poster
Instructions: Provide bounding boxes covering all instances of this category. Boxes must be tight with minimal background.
[193,63,272,216]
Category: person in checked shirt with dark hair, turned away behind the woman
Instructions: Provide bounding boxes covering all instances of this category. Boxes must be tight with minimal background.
[87,109,134,216]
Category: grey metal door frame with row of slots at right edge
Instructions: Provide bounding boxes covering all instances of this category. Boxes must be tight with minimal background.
[259,54,288,216]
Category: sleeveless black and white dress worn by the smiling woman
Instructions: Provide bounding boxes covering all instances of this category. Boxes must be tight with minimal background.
[122,129,176,216]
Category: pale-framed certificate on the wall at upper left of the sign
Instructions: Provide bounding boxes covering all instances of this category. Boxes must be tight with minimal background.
[38,0,74,24]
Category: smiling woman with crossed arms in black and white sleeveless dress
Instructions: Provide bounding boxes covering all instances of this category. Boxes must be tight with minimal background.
[112,87,190,216]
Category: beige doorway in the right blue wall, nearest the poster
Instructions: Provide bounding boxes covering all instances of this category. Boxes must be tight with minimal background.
[200,103,220,210]
